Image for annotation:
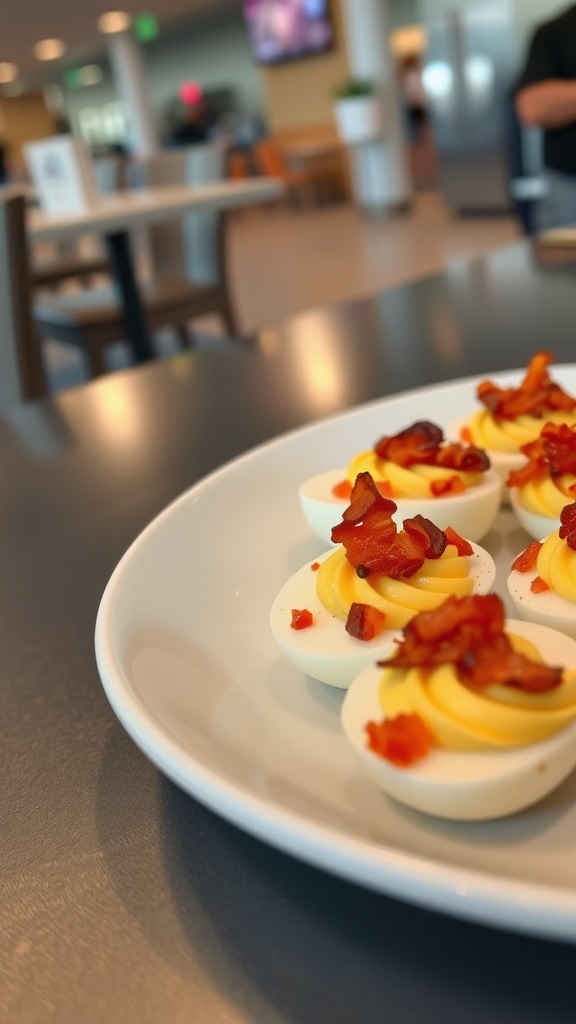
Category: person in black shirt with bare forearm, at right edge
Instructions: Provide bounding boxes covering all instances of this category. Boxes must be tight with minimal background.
[516,4,576,229]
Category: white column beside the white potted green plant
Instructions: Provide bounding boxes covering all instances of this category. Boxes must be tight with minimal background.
[340,0,411,210]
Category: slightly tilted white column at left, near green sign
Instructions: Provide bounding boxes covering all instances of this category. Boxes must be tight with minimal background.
[108,31,158,157]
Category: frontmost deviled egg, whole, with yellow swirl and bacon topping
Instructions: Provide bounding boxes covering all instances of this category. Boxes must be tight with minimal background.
[341,594,576,821]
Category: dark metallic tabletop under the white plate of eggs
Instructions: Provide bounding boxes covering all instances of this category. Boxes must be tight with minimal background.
[0,245,576,1024]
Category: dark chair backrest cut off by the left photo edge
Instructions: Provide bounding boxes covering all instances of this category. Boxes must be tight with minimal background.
[0,188,46,410]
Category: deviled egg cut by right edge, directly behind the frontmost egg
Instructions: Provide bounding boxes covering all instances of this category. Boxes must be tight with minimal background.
[507,502,576,639]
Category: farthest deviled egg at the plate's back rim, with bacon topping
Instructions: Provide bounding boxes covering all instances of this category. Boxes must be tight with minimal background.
[450,352,576,494]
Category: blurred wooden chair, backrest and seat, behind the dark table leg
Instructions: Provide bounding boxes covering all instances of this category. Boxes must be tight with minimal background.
[34,139,236,377]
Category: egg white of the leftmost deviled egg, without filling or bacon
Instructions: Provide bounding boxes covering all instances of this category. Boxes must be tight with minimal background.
[270,544,496,689]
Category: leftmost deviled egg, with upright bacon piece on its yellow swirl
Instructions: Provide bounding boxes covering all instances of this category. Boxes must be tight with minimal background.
[270,473,496,688]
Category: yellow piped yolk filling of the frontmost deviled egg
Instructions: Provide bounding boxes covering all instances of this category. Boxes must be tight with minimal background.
[379,636,576,751]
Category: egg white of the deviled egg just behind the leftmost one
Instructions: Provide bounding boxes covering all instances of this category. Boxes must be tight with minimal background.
[298,469,502,544]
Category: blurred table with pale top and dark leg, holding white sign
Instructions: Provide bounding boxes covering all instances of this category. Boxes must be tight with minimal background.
[27,177,283,362]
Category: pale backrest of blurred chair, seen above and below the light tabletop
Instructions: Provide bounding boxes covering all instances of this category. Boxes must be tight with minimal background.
[130,143,227,285]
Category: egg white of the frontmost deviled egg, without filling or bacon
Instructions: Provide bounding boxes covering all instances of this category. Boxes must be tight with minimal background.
[341,620,576,821]
